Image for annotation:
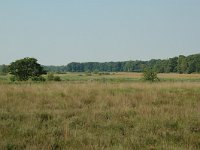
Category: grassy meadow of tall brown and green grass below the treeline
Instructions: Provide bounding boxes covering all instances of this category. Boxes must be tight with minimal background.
[0,73,200,150]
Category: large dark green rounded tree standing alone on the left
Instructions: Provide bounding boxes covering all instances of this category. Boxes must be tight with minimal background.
[9,57,46,81]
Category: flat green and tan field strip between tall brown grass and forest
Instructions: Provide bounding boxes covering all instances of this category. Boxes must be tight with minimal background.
[60,72,200,82]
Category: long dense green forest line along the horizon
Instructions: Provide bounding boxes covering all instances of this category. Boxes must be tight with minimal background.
[0,54,200,73]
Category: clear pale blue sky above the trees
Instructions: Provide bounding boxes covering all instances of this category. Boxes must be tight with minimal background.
[0,0,200,65]
